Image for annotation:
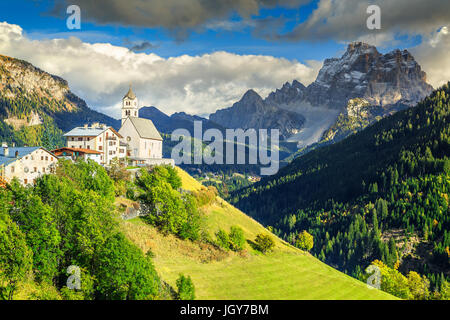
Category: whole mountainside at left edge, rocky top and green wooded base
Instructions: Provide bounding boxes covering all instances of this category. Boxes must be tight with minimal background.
[0,55,120,148]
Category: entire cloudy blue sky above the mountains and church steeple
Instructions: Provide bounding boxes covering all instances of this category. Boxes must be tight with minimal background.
[0,0,450,118]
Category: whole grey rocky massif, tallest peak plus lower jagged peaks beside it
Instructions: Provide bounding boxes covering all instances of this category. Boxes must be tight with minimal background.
[210,42,433,144]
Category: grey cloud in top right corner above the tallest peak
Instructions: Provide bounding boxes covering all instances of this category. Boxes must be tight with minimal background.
[272,0,450,42]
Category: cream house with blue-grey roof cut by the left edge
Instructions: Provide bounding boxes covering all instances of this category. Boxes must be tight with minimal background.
[0,144,58,185]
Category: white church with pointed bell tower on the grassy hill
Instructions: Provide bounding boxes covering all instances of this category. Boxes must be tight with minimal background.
[119,86,173,165]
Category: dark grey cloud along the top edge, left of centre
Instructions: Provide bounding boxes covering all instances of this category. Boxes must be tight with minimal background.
[51,0,311,38]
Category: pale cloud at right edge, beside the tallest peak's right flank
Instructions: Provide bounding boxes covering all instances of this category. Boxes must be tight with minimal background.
[411,27,450,88]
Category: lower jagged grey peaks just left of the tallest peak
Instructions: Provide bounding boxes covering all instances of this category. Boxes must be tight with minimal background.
[209,90,305,139]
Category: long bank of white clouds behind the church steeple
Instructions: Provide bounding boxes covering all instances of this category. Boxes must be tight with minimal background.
[0,22,320,118]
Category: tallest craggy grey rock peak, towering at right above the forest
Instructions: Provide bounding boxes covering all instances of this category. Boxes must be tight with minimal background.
[305,42,433,109]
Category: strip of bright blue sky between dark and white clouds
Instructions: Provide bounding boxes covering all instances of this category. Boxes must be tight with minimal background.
[0,0,346,61]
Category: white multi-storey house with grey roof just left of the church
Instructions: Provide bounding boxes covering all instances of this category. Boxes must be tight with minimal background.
[64,123,126,165]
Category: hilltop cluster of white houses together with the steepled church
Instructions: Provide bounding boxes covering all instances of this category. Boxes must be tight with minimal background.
[0,86,175,185]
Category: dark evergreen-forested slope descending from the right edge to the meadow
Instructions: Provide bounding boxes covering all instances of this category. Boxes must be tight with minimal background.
[232,84,450,298]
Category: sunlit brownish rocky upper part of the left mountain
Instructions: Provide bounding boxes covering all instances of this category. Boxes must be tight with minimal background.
[0,55,120,131]
